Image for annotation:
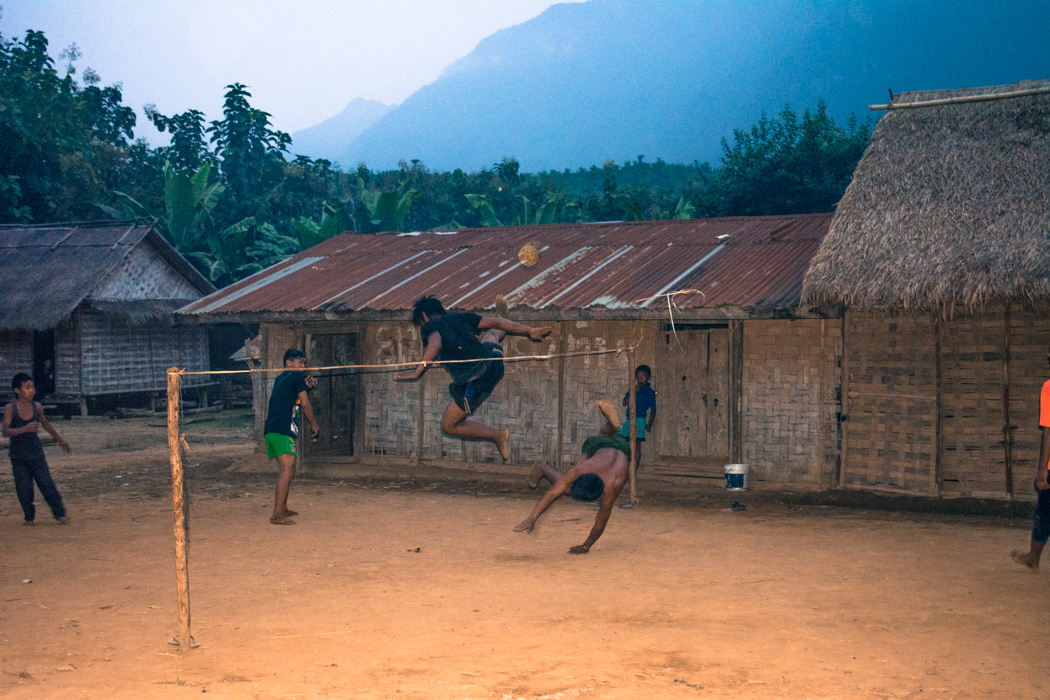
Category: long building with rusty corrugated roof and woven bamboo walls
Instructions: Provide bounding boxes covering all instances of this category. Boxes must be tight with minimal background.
[180,214,842,488]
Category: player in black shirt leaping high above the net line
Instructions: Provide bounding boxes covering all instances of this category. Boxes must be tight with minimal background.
[397,296,550,460]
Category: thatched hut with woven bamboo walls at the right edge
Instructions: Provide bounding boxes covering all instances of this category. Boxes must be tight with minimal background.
[804,81,1050,499]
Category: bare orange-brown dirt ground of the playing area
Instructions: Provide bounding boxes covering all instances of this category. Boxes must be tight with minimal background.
[0,415,1050,700]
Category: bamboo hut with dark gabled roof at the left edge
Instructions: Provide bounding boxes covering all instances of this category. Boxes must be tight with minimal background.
[0,221,215,411]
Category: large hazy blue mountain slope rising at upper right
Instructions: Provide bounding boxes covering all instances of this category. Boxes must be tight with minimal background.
[338,0,1050,172]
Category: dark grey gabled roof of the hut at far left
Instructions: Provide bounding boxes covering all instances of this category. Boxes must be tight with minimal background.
[0,221,215,331]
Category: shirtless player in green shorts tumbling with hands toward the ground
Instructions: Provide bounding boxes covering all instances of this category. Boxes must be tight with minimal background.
[515,401,631,554]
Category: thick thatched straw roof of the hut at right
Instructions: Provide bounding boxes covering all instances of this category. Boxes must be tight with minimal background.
[802,80,1050,312]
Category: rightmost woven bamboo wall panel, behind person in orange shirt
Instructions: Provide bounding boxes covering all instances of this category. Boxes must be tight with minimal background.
[1009,309,1050,501]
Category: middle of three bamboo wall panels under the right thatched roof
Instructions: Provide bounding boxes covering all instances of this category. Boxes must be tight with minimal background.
[941,309,1006,497]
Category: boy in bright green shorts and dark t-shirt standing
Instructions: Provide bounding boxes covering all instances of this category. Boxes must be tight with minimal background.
[263,347,318,525]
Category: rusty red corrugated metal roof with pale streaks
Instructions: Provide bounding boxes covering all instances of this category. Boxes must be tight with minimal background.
[181,214,832,314]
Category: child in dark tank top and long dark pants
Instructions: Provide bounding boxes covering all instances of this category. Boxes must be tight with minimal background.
[2,372,70,525]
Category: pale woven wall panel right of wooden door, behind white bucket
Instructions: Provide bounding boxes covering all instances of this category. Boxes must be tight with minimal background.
[742,320,841,485]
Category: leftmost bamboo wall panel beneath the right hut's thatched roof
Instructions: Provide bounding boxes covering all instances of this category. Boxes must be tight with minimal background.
[842,312,938,494]
